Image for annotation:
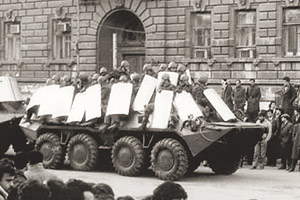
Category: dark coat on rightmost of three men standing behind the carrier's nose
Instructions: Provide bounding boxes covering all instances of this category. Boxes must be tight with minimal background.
[246,85,261,113]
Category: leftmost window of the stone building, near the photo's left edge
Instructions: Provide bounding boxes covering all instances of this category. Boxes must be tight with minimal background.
[4,22,21,60]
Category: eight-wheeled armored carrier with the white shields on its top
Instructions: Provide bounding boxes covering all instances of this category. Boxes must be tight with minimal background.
[20,72,264,180]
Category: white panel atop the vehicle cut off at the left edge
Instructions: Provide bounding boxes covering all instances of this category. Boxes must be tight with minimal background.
[0,76,22,102]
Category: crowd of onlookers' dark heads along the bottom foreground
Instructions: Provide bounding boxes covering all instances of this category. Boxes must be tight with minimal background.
[0,151,187,200]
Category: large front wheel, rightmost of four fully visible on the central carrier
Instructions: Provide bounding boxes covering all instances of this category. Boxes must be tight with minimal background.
[151,138,188,181]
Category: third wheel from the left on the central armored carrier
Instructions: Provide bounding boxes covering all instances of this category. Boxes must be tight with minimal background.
[111,136,145,176]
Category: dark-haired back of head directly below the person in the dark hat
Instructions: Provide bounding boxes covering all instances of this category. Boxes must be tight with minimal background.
[20,180,51,200]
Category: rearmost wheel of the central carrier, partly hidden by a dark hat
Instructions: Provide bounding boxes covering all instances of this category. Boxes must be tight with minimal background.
[35,133,65,169]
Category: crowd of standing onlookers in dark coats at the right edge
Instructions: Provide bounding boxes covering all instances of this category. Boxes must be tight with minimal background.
[222,77,300,172]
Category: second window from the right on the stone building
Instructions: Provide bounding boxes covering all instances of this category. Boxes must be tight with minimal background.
[236,11,256,58]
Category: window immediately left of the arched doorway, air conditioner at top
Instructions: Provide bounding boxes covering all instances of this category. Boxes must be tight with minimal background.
[52,20,72,60]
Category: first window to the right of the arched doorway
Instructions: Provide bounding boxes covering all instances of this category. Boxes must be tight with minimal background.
[191,13,211,58]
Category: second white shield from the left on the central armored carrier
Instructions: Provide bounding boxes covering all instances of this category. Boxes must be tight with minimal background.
[38,85,59,116]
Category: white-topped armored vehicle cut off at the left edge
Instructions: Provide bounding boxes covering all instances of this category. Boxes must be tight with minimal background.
[0,76,26,157]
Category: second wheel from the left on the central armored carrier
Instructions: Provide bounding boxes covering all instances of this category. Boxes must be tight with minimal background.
[68,134,98,171]
